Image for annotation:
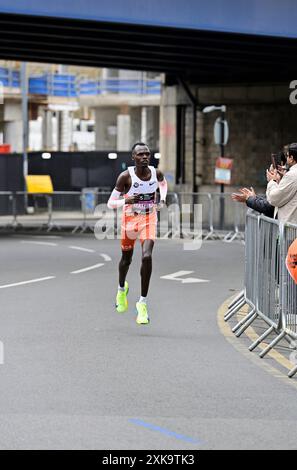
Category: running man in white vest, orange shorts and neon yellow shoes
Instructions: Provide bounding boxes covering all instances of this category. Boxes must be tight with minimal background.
[107,142,167,325]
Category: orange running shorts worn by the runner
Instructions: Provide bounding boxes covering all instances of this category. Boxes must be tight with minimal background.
[121,211,158,251]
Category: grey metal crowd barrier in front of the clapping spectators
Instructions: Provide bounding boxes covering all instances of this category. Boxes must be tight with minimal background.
[224,212,297,377]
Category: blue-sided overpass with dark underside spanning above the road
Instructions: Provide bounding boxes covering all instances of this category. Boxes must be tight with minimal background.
[0,0,297,84]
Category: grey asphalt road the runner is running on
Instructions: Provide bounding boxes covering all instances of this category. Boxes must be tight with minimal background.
[0,234,297,450]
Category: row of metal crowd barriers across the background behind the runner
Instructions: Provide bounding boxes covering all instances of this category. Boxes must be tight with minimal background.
[0,188,246,242]
